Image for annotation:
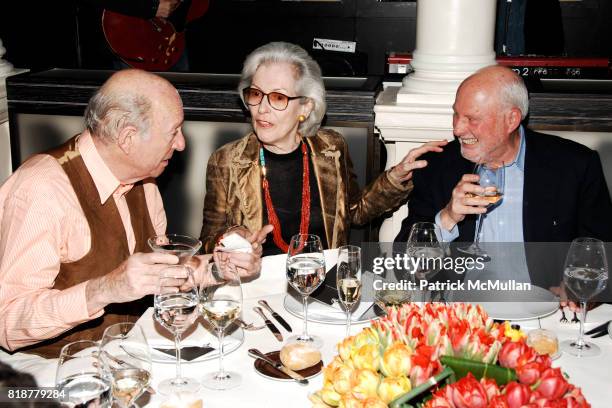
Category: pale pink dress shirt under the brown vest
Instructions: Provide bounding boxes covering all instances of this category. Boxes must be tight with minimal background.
[0,132,166,350]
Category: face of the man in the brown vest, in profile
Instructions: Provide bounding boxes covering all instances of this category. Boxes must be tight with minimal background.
[131,90,185,179]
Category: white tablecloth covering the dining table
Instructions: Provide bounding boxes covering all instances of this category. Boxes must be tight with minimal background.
[0,254,612,408]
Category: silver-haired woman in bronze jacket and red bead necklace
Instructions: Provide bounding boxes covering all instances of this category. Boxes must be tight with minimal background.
[201,42,446,255]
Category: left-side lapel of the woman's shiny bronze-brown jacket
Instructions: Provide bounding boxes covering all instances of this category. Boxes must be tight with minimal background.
[231,133,263,232]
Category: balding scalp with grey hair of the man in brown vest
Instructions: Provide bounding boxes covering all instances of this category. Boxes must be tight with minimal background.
[85,69,180,143]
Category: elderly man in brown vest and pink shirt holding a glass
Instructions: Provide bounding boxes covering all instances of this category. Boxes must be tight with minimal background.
[0,70,260,357]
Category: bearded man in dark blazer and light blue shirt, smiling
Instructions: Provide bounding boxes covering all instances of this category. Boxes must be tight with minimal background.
[396,66,612,290]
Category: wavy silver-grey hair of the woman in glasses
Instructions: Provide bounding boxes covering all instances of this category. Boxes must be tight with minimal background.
[238,42,327,136]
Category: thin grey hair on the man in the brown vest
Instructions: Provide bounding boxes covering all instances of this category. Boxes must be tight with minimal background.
[85,87,152,143]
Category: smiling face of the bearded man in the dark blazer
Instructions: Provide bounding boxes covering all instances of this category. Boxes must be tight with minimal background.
[453,84,514,163]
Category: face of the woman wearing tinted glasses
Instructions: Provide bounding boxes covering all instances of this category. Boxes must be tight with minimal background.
[248,62,311,146]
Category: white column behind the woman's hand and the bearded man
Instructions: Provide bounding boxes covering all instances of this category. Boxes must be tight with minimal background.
[374,0,496,241]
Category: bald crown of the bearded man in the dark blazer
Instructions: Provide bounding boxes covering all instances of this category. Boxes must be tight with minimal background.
[457,65,529,119]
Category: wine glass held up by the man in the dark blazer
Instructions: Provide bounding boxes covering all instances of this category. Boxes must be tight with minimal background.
[457,163,505,260]
